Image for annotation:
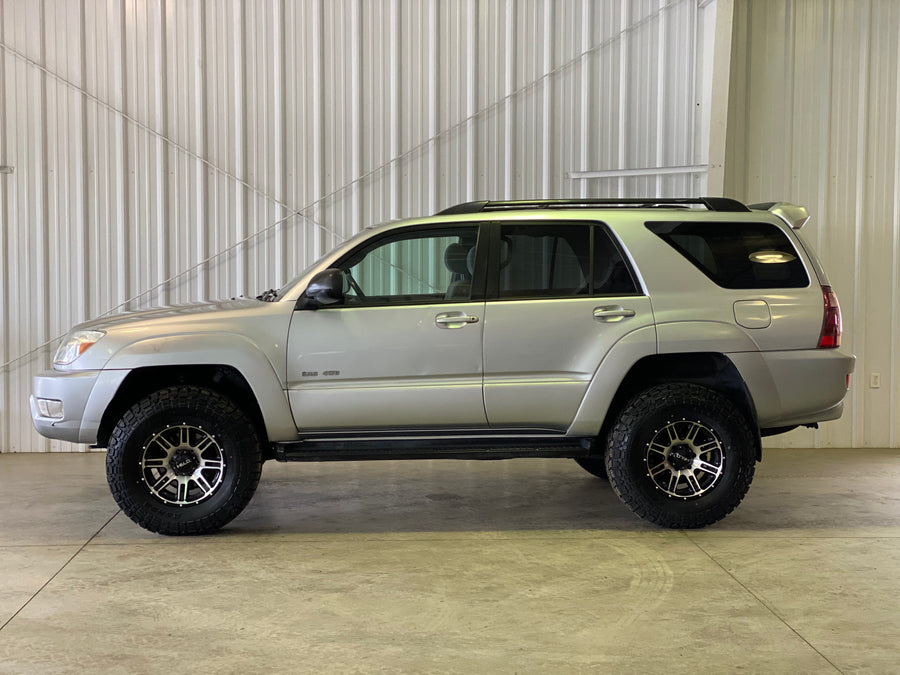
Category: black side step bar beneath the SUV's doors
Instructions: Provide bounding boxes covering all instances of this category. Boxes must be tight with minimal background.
[275,438,592,462]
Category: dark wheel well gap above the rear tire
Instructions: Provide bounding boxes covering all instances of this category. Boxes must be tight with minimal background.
[600,352,762,461]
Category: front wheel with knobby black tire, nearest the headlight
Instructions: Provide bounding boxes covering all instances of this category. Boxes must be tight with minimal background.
[106,386,262,535]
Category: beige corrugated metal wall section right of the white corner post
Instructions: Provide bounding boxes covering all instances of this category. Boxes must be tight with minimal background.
[725,0,900,447]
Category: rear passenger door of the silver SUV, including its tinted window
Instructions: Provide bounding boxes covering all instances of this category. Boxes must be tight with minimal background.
[484,221,653,430]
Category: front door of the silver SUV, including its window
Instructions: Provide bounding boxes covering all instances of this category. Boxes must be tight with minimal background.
[287,225,487,432]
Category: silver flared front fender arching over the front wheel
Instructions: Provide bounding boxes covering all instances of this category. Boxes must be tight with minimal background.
[103,333,297,441]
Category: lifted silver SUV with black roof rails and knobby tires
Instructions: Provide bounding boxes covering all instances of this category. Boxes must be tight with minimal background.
[31,198,854,534]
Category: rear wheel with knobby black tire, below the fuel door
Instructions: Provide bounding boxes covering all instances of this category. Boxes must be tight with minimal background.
[606,384,756,528]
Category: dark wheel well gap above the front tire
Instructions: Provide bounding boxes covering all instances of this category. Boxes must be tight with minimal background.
[97,365,268,448]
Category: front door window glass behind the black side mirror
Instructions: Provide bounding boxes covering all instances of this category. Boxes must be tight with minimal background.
[340,226,478,305]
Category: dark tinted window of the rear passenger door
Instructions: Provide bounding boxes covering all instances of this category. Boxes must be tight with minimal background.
[498,224,635,298]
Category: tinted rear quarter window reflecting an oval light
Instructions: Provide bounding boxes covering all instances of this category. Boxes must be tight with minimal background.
[647,222,809,289]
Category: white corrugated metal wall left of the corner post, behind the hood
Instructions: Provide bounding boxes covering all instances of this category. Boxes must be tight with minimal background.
[0,0,716,451]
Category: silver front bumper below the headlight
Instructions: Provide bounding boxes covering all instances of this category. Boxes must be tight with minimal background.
[31,370,129,444]
